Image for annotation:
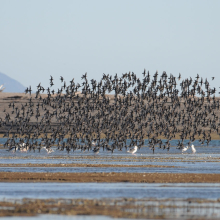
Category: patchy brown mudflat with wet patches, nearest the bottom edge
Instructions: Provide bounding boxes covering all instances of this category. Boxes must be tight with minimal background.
[0,198,219,220]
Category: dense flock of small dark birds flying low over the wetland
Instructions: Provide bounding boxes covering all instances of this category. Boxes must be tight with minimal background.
[0,70,220,154]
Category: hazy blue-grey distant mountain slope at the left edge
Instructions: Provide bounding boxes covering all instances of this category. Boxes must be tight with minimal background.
[0,73,26,93]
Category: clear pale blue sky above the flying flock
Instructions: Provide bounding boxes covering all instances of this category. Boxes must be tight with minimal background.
[0,0,220,93]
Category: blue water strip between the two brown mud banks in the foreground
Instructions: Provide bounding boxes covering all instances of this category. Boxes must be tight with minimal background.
[0,183,220,200]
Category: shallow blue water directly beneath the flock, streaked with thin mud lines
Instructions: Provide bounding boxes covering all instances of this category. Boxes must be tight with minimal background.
[0,146,220,173]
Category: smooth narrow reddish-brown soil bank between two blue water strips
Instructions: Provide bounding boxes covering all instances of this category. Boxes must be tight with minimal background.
[0,172,220,183]
